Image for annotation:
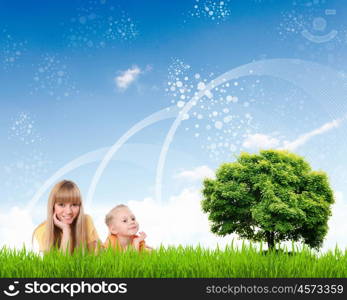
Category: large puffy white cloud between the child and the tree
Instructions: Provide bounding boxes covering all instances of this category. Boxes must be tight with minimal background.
[128,188,236,248]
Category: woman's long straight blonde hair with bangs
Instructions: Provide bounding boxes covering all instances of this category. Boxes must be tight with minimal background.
[34,180,87,252]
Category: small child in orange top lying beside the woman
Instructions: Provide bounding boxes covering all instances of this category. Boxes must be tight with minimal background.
[104,204,152,251]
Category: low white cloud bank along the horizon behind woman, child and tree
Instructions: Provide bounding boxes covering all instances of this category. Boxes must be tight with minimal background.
[0,188,347,251]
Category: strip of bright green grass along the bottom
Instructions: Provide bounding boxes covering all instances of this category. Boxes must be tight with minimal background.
[0,245,347,278]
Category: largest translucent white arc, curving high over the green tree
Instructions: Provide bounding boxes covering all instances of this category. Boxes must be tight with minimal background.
[155,59,347,203]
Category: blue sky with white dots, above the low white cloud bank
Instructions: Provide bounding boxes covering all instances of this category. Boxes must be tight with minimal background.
[0,0,347,248]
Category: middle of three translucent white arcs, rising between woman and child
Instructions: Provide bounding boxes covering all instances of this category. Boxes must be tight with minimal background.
[86,105,179,209]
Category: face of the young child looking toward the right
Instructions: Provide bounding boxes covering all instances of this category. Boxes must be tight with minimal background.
[109,207,139,236]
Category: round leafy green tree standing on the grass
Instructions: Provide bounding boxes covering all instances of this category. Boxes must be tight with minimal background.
[201,150,334,249]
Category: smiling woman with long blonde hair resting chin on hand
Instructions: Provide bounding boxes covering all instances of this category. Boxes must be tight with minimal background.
[33,180,99,253]
